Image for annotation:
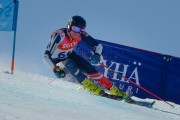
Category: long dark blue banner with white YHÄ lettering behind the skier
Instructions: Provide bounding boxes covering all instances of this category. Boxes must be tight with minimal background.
[76,40,180,104]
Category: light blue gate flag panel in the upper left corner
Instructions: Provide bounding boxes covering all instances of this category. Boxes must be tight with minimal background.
[0,0,17,31]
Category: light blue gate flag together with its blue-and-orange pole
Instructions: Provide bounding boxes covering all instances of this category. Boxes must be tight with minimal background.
[0,0,19,74]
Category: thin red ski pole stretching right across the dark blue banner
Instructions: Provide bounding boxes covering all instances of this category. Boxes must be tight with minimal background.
[99,62,175,108]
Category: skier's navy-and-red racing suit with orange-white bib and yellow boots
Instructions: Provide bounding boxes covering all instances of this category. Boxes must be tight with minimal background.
[44,28,126,96]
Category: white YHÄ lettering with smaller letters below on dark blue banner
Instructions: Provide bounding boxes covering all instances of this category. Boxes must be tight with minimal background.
[101,59,141,94]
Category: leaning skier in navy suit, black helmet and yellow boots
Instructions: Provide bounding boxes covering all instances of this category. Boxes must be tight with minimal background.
[44,15,127,98]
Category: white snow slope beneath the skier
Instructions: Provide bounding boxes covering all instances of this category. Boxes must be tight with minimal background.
[0,71,180,120]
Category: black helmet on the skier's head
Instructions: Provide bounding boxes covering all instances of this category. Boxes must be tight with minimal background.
[67,15,86,30]
